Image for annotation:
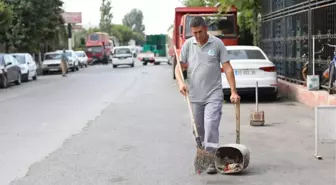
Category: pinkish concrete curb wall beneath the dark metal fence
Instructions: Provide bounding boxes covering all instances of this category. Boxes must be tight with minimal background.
[278,79,336,108]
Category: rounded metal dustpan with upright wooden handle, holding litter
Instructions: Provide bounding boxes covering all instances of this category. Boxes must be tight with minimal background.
[215,102,250,174]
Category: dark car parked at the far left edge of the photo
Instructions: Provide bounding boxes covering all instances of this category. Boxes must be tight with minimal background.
[0,53,21,88]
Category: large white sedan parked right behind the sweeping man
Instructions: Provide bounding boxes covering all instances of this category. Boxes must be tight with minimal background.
[222,46,278,100]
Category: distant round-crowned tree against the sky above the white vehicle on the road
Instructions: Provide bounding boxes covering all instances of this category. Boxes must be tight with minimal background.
[122,9,145,35]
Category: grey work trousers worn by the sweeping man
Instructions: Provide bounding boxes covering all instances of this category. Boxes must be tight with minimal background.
[191,100,223,152]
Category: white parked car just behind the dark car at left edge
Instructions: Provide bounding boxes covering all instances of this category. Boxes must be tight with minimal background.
[12,53,37,82]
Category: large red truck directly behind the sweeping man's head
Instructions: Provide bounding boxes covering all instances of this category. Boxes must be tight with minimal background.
[169,6,239,79]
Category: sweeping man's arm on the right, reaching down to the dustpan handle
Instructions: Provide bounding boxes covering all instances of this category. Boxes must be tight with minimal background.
[219,43,237,94]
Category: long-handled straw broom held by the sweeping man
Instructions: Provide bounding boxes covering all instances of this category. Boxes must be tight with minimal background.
[174,46,214,174]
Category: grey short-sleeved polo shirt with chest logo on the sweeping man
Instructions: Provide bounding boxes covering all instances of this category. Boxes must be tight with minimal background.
[181,35,228,103]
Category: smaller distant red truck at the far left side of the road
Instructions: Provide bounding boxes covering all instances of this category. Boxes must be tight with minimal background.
[86,32,113,64]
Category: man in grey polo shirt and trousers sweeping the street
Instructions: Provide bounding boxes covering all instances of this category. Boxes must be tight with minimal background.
[175,16,240,174]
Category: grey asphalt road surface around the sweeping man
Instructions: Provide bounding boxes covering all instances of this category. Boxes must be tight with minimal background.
[0,61,336,185]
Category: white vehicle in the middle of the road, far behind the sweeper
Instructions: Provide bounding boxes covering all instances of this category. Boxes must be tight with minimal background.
[112,46,135,68]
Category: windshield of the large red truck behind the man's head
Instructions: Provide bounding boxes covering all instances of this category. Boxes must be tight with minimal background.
[185,14,236,38]
